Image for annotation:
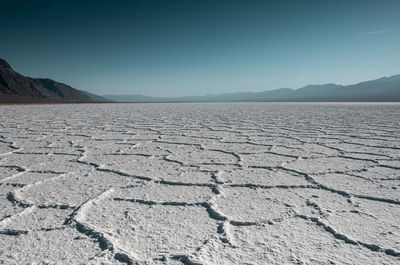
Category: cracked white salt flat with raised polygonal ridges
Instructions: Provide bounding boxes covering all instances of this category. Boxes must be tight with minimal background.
[0,103,400,265]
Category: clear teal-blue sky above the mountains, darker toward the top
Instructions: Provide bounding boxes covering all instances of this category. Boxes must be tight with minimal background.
[0,0,400,96]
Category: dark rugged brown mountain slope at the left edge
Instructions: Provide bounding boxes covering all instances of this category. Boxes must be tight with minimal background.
[0,58,94,102]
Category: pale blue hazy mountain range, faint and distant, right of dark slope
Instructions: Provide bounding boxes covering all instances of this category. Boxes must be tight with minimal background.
[104,75,400,102]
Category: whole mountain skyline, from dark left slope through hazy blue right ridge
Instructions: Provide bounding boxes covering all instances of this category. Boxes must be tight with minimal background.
[0,58,400,103]
